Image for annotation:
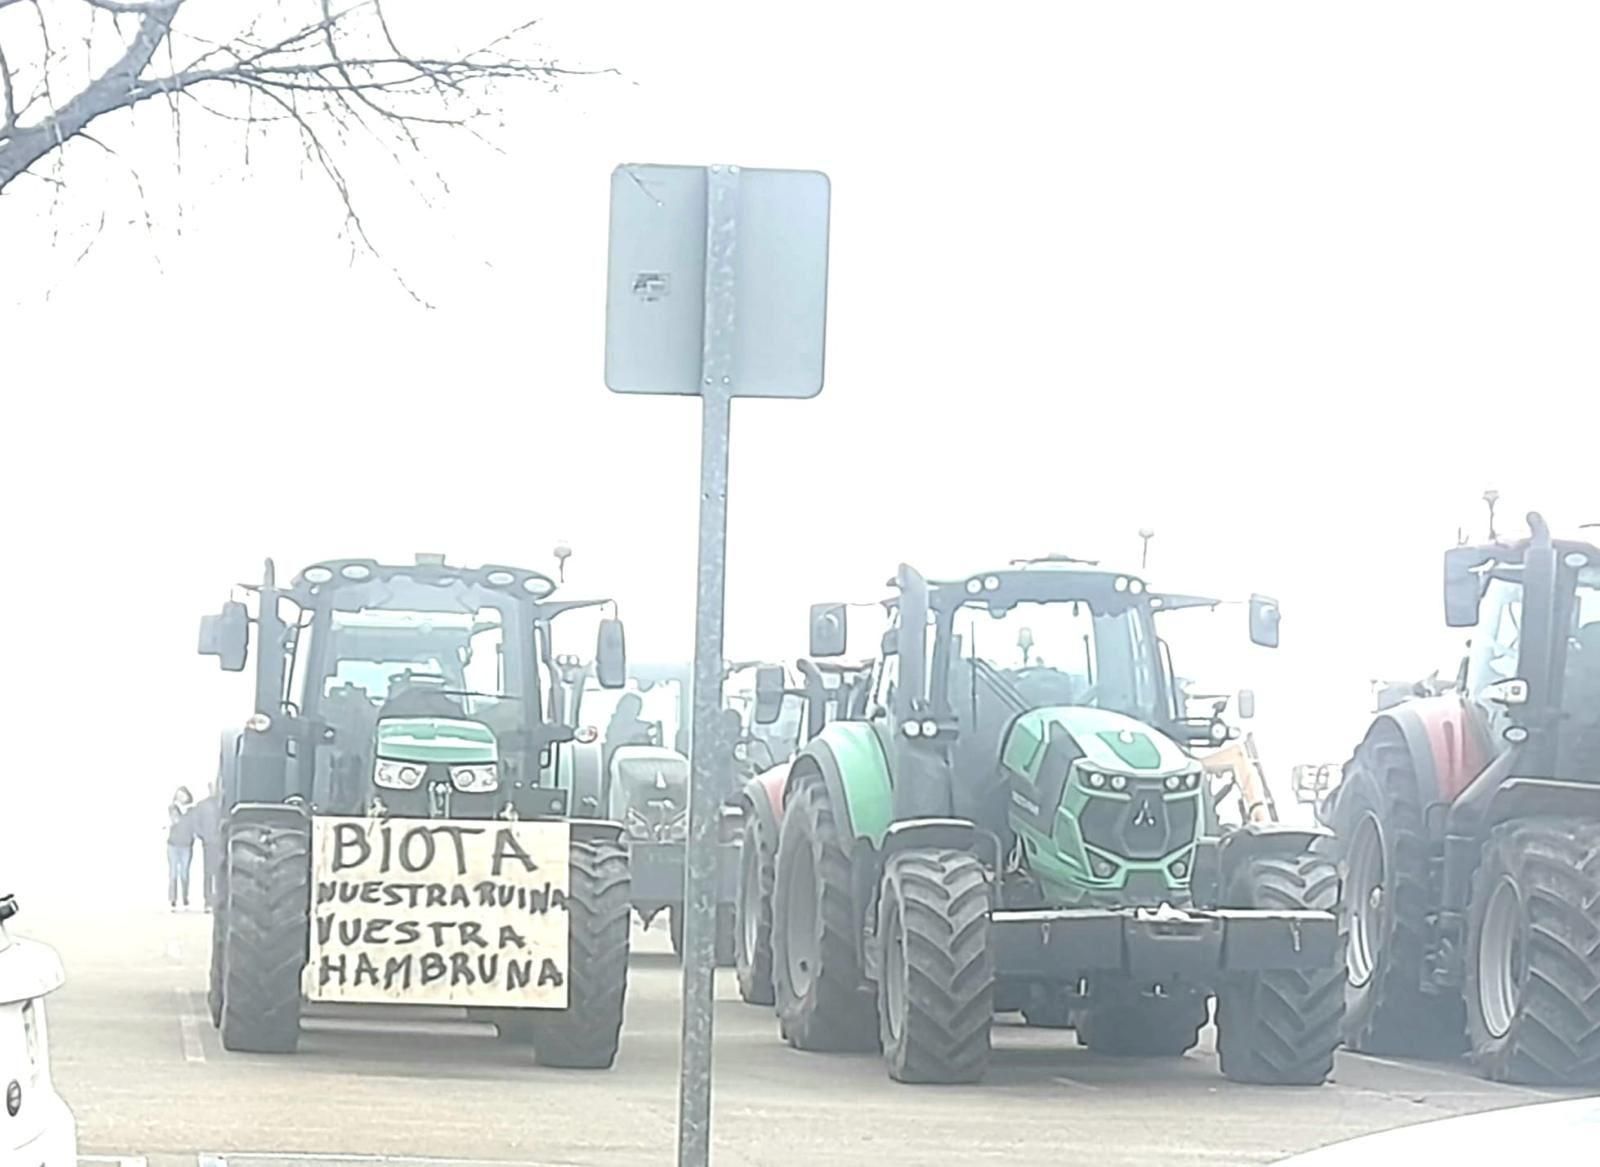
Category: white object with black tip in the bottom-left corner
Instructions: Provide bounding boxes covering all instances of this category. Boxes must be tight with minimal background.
[0,896,78,1167]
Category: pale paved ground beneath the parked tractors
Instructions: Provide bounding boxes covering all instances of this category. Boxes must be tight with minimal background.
[19,908,1587,1167]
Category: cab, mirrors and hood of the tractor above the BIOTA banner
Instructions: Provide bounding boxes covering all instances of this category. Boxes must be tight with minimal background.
[200,555,624,818]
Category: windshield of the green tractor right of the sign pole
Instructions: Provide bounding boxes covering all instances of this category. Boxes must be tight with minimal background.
[950,600,1166,720]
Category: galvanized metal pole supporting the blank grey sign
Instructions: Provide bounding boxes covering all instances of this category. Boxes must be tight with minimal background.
[678,166,739,1167]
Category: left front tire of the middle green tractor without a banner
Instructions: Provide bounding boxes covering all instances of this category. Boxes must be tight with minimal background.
[877,848,995,1082]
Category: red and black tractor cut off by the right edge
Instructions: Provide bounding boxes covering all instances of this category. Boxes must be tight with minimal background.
[1320,514,1600,1085]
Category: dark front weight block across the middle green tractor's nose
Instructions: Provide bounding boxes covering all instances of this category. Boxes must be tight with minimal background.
[989,908,1339,983]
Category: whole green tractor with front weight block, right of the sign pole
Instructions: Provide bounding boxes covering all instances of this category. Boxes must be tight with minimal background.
[771,562,1344,1085]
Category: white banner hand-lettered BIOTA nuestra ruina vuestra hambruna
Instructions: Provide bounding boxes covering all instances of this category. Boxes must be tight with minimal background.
[304,818,570,1009]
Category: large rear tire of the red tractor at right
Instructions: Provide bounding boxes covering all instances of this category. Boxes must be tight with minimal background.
[1331,727,1466,1057]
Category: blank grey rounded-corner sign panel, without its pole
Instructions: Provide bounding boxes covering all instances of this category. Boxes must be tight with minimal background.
[605,165,830,397]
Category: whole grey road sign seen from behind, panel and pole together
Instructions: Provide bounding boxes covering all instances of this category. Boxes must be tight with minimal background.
[605,166,829,1167]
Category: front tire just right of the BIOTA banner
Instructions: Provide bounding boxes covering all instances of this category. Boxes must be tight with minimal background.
[531,839,632,1069]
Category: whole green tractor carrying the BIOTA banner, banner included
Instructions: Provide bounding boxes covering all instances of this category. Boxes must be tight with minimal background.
[200,555,629,1068]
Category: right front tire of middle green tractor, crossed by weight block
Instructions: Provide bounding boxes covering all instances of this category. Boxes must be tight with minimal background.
[1216,853,1344,1085]
